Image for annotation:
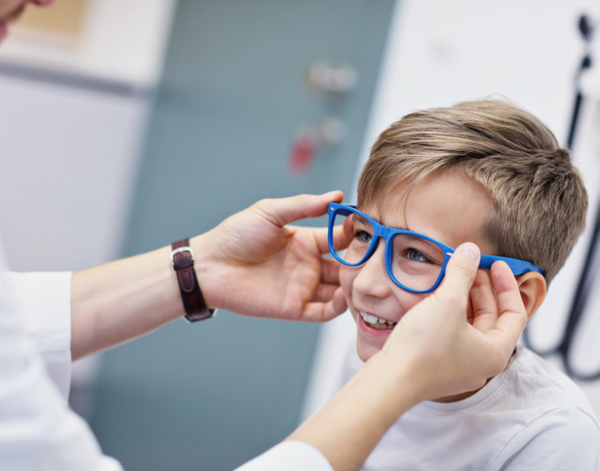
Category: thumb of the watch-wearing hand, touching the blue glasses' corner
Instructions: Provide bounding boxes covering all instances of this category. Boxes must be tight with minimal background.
[256,191,344,227]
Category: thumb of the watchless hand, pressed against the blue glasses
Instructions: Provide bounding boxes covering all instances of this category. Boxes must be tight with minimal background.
[436,242,481,306]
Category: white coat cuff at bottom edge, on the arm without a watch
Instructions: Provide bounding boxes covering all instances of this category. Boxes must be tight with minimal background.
[235,441,333,471]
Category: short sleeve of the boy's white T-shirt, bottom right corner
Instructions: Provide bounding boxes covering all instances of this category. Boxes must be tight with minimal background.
[490,407,600,471]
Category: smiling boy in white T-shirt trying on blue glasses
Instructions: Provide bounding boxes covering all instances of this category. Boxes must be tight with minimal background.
[336,100,600,471]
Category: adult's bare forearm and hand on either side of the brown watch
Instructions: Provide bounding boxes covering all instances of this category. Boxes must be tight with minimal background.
[71,191,346,359]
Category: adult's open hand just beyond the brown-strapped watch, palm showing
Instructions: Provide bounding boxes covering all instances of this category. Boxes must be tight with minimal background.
[192,191,349,322]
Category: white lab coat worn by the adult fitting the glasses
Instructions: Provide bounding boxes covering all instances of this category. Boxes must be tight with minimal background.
[0,243,333,471]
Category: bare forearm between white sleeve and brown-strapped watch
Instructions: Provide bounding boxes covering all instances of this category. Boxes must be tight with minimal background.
[71,238,209,360]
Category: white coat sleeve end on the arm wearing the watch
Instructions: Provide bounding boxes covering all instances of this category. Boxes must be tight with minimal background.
[6,272,71,401]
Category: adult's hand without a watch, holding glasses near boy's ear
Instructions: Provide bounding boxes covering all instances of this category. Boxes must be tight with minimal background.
[380,243,527,400]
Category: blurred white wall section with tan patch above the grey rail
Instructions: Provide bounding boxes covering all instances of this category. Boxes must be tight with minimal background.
[0,0,176,87]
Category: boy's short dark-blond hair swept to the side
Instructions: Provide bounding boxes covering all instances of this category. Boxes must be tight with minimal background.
[358,100,588,283]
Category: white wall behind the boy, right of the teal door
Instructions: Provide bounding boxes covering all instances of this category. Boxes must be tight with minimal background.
[304,0,600,416]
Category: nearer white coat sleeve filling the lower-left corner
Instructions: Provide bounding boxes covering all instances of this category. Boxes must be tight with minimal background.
[0,268,122,471]
